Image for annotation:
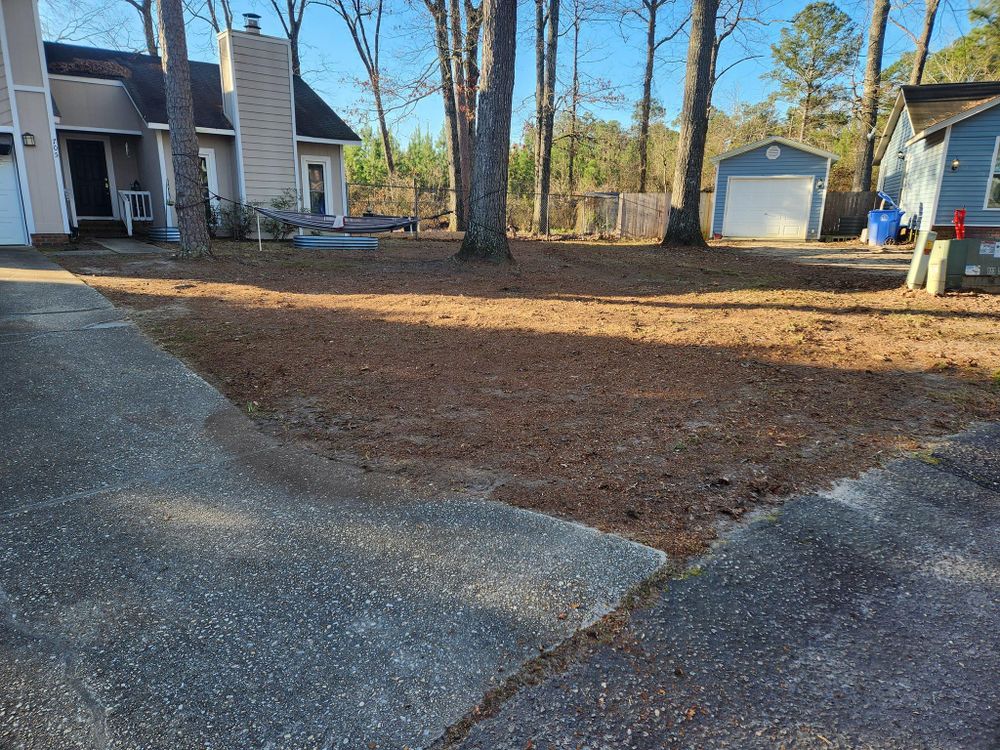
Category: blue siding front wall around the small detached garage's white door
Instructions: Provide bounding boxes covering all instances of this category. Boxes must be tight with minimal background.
[712,144,827,239]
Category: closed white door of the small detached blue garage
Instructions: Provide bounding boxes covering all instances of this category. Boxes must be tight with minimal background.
[722,177,813,240]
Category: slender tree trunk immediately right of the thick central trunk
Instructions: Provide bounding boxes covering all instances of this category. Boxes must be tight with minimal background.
[532,0,560,234]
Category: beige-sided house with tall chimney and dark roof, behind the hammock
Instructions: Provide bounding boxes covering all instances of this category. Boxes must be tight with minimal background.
[0,0,360,250]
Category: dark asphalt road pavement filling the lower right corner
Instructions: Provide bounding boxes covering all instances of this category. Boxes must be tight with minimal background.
[459,426,1000,750]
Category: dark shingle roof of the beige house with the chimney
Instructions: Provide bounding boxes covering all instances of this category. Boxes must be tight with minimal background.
[45,42,361,141]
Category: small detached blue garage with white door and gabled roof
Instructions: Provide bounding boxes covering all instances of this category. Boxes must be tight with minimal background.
[712,136,837,240]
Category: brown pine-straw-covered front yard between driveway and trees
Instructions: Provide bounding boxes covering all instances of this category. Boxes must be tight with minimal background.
[61,239,1000,556]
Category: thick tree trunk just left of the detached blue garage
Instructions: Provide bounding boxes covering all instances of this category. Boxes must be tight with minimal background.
[662,0,719,246]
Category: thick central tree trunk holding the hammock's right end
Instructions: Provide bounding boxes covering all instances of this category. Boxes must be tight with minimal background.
[457,0,517,263]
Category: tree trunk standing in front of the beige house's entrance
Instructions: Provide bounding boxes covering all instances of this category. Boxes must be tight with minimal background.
[159,0,210,257]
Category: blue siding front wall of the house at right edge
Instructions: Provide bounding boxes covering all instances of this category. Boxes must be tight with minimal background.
[934,105,1000,227]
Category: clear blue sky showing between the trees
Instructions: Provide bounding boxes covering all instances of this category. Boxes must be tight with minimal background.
[41,0,968,141]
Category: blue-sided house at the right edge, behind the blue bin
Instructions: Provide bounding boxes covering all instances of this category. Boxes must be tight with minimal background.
[875,81,1000,238]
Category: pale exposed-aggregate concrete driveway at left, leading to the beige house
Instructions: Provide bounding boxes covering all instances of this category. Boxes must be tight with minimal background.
[0,250,663,750]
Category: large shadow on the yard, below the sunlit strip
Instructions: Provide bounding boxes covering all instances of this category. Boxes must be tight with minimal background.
[62,280,997,555]
